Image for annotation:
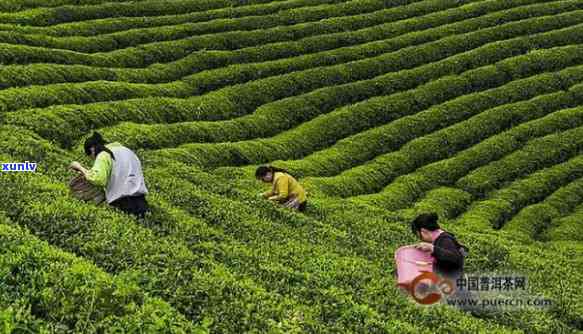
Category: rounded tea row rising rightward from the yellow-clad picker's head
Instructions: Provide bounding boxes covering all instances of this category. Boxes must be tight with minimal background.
[276,67,578,176]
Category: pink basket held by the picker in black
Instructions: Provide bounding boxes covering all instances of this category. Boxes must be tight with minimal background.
[395,246,434,285]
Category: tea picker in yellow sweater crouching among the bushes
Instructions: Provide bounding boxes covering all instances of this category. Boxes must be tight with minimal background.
[255,166,307,211]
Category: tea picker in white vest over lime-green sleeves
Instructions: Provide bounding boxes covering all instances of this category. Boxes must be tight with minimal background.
[70,132,149,217]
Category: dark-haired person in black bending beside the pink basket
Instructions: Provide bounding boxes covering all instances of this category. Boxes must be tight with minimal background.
[411,213,467,282]
